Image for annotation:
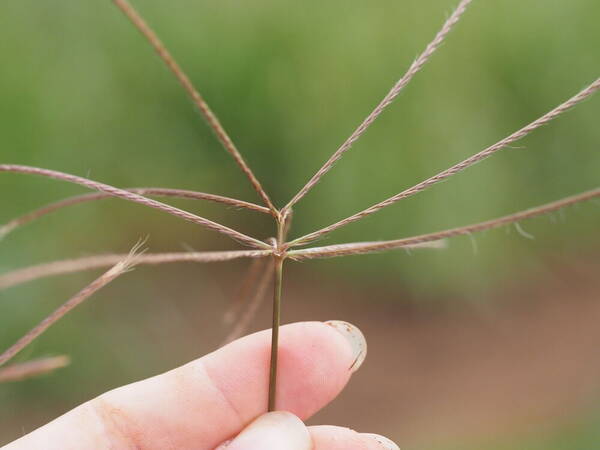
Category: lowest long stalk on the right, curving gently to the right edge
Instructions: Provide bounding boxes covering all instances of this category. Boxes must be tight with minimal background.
[288,188,600,261]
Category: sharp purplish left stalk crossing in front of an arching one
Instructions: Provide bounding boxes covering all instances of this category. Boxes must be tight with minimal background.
[0,164,269,248]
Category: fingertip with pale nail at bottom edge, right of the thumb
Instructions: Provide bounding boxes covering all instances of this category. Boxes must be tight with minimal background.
[310,425,400,450]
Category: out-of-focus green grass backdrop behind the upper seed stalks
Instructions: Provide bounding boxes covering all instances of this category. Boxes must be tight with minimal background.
[0,0,600,293]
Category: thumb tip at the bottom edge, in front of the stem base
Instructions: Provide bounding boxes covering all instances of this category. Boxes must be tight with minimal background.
[217,411,312,450]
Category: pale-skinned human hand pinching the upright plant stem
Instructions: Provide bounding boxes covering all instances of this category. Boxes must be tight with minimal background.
[4,321,398,450]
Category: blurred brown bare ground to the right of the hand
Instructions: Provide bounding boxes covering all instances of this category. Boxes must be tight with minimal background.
[302,253,600,448]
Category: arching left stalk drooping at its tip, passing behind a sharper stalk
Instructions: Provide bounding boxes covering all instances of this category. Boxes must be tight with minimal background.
[0,187,270,238]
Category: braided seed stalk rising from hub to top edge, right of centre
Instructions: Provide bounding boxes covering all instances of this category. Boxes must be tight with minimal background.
[282,0,472,211]
